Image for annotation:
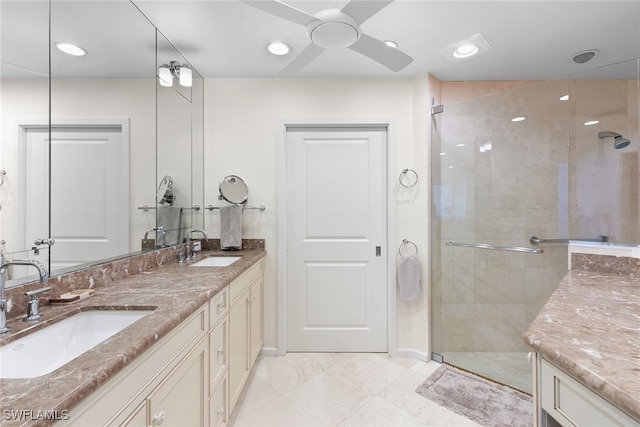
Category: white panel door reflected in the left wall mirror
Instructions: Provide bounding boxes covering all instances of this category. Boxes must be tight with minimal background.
[26,126,129,271]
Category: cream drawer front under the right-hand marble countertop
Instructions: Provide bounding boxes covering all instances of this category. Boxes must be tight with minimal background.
[540,359,640,426]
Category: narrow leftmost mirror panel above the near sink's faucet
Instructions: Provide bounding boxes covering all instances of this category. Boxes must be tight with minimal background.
[0,0,49,280]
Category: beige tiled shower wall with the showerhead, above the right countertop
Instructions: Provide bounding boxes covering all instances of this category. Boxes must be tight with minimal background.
[570,75,640,243]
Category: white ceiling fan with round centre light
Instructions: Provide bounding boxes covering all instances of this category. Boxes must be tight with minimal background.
[242,0,413,74]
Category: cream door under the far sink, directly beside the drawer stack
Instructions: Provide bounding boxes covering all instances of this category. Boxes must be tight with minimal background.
[229,289,250,411]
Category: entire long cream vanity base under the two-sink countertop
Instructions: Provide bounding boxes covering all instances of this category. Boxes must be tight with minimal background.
[60,260,263,427]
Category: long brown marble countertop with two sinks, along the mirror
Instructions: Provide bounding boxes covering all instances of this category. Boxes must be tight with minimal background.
[0,250,266,426]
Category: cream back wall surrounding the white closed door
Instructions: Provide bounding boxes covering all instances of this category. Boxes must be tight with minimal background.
[205,77,430,356]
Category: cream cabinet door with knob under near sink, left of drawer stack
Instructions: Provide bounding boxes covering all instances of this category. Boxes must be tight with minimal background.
[149,339,209,427]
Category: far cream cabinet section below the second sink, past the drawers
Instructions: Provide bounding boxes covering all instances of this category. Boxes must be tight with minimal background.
[229,261,263,412]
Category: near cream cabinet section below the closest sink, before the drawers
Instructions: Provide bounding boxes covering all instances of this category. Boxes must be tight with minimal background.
[63,306,209,426]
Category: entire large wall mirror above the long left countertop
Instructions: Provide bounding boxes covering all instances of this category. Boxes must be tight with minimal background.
[0,0,203,285]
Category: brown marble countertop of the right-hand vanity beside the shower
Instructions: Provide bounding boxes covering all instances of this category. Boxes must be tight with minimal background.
[524,270,640,420]
